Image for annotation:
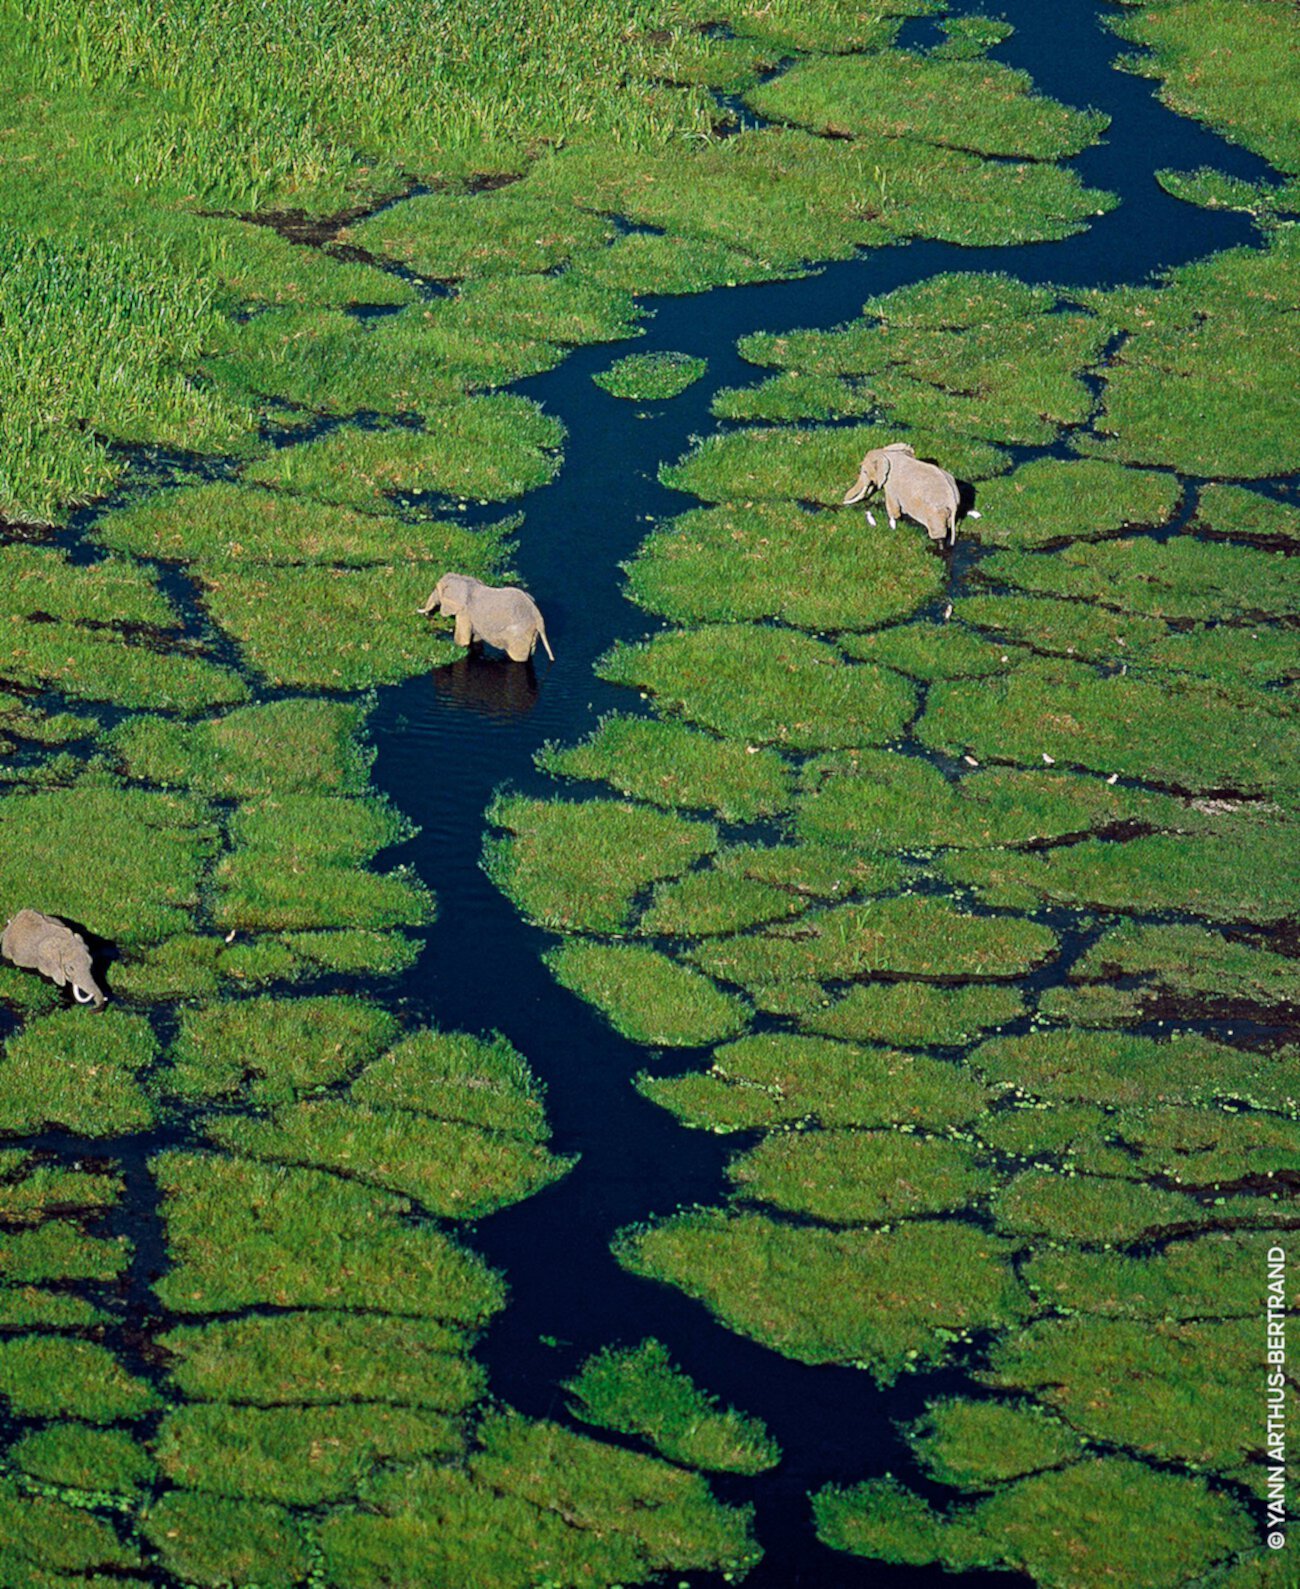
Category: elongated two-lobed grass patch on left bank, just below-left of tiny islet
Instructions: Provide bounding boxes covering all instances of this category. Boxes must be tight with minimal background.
[246,396,564,507]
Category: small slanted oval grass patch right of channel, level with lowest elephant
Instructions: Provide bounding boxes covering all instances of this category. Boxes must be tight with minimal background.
[544,944,749,1047]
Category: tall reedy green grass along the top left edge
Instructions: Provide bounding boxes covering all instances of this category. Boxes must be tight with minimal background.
[0,0,709,203]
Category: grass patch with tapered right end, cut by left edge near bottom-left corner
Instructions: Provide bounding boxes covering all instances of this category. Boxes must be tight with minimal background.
[0,1335,162,1424]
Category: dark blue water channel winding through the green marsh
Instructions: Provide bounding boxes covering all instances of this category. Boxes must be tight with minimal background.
[354,0,1265,1589]
